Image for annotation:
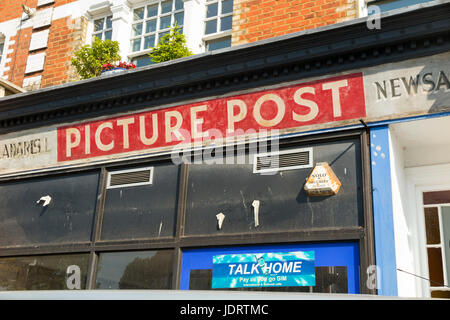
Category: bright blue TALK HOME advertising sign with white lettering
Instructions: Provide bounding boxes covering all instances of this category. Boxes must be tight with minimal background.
[212,251,316,289]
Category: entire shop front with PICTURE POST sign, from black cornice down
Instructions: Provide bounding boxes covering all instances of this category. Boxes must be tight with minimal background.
[0,3,450,296]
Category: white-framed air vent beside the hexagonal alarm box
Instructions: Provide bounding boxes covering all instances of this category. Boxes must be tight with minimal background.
[253,148,313,173]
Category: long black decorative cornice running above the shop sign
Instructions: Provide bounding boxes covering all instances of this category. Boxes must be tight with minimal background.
[0,1,450,133]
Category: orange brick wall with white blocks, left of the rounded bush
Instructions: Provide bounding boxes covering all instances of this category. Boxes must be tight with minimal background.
[0,0,81,90]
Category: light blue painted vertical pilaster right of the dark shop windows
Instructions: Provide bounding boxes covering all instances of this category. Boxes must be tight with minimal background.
[370,126,398,296]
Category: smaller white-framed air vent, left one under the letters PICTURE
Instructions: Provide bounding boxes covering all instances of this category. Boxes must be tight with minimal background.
[107,167,153,189]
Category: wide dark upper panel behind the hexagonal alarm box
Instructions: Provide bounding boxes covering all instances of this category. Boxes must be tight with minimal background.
[185,139,363,235]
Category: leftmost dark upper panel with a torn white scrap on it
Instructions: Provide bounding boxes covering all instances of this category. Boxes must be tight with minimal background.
[0,172,99,246]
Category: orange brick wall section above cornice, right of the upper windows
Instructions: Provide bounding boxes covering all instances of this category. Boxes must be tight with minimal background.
[232,0,358,45]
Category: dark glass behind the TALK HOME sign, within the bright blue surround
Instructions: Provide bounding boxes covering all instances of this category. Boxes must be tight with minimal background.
[189,267,348,293]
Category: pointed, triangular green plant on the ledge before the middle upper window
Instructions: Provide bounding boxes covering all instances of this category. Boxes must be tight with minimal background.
[149,24,193,63]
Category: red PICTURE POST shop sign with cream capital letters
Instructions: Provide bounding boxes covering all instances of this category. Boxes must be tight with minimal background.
[58,73,366,161]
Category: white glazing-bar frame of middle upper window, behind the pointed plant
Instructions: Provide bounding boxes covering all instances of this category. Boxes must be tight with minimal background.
[128,0,185,56]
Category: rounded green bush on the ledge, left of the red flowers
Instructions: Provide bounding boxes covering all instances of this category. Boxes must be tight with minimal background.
[71,37,121,79]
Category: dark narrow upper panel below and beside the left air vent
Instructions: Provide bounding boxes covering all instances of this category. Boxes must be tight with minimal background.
[101,163,179,240]
